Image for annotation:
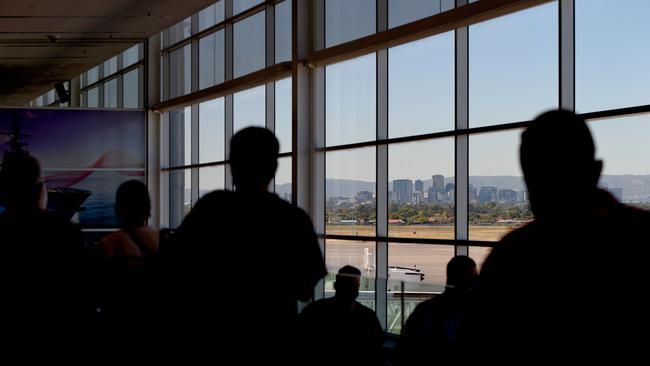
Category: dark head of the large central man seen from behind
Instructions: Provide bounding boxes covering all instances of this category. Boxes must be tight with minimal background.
[230,127,280,191]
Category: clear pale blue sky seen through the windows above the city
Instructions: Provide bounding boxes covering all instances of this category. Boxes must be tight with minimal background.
[202,0,650,182]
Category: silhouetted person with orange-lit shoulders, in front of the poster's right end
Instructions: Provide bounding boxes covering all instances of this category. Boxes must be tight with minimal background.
[95,180,158,334]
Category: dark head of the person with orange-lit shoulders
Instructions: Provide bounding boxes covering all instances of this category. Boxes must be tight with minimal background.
[115,180,151,227]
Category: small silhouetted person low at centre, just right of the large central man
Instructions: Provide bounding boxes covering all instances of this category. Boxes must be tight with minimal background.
[301,266,384,366]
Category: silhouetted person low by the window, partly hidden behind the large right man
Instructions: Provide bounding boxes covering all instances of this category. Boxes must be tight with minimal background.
[397,256,478,365]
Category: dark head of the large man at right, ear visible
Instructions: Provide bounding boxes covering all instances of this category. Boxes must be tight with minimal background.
[520,110,602,219]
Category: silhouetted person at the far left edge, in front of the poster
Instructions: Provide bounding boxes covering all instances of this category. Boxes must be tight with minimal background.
[0,152,92,342]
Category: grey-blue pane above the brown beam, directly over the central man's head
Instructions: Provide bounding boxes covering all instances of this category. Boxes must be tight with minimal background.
[234,11,266,78]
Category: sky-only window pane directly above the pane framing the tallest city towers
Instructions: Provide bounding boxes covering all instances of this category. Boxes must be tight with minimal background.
[388,32,455,137]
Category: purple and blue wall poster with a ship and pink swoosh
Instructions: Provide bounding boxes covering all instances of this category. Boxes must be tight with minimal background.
[0,108,146,228]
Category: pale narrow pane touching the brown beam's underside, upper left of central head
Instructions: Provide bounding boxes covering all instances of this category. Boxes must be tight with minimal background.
[199,98,226,163]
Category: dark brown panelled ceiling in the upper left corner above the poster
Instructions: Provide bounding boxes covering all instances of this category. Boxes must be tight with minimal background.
[0,0,215,106]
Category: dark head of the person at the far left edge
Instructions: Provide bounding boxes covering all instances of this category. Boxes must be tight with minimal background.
[0,153,47,212]
